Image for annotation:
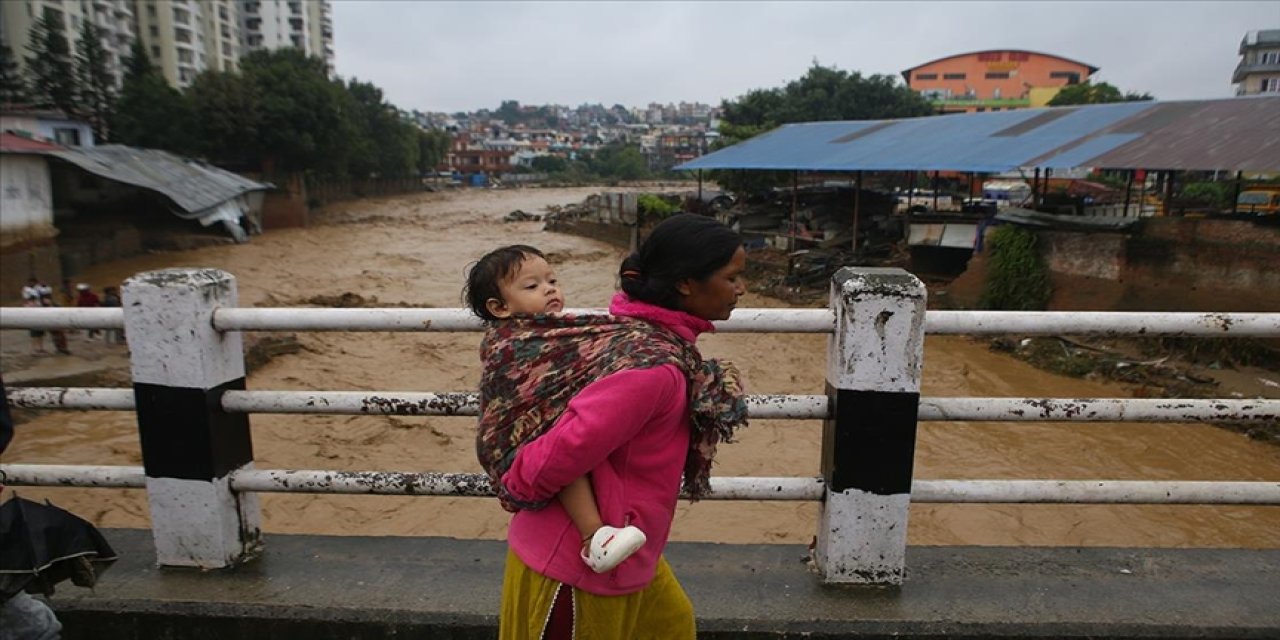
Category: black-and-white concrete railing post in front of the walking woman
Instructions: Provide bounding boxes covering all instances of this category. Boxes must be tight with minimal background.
[814,268,925,585]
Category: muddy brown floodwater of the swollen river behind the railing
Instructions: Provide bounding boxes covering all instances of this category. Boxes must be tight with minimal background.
[5,188,1280,548]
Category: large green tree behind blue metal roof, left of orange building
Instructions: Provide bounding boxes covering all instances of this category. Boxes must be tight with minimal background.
[712,61,933,193]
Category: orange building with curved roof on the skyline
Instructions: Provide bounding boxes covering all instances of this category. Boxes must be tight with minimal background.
[902,49,1098,113]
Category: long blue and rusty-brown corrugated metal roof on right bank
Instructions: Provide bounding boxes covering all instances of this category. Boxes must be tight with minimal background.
[676,96,1280,173]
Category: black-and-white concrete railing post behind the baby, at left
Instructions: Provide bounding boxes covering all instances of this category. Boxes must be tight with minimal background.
[122,269,261,568]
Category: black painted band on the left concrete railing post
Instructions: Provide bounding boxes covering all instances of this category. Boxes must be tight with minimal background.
[133,378,253,481]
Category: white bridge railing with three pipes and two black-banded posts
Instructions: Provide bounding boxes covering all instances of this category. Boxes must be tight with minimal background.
[0,269,1280,584]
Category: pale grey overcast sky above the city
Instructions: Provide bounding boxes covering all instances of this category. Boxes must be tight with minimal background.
[333,0,1280,113]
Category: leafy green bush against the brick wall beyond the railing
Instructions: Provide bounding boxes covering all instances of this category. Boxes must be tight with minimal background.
[978,225,1053,311]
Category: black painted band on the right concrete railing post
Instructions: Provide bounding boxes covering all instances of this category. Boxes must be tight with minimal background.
[822,384,920,495]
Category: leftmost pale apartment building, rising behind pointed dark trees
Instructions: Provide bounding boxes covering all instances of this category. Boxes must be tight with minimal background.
[0,0,137,87]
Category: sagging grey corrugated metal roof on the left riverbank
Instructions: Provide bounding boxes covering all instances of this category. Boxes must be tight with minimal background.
[45,145,273,218]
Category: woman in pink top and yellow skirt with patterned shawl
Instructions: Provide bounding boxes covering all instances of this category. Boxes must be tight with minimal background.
[480,214,746,640]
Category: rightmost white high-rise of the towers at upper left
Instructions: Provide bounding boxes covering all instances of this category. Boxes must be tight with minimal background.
[238,0,333,76]
